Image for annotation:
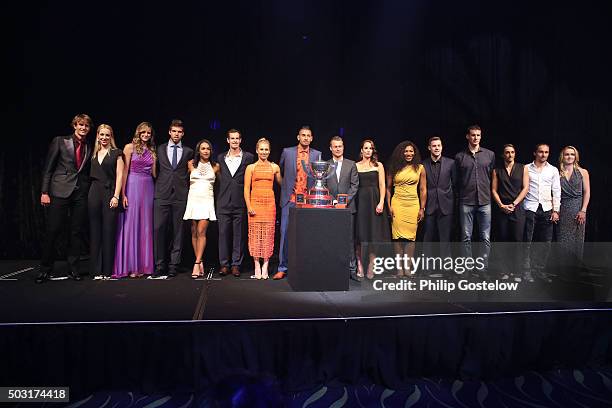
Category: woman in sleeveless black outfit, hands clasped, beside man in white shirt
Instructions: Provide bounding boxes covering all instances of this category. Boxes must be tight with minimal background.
[491,144,529,282]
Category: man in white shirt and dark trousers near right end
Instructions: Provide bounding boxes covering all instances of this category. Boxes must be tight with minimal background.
[523,143,561,282]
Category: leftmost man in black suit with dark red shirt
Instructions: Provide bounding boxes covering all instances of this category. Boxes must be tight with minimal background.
[36,114,93,283]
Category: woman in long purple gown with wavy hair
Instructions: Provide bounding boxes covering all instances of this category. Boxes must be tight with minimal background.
[113,122,156,279]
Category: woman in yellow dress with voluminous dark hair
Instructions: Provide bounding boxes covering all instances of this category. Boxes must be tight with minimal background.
[386,141,427,277]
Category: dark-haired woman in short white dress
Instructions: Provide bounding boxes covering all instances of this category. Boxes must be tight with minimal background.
[183,139,220,279]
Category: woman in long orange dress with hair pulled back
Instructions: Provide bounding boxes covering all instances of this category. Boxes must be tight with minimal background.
[244,138,281,279]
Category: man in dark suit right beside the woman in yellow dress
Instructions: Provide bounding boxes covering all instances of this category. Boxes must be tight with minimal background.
[423,136,456,274]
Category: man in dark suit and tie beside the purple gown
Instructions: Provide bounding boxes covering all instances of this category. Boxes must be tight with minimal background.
[149,119,193,279]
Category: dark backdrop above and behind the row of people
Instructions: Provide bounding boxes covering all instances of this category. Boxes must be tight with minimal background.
[0,0,612,258]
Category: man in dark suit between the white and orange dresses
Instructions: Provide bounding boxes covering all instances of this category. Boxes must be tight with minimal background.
[216,129,255,278]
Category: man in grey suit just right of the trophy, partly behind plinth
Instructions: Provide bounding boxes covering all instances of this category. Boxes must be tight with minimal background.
[327,136,360,280]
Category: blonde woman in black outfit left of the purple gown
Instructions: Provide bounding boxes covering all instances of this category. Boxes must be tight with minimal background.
[87,124,124,280]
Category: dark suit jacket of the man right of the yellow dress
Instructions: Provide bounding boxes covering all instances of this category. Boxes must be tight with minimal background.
[423,156,457,215]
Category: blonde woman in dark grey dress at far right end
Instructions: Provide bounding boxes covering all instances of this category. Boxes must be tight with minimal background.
[557,146,591,259]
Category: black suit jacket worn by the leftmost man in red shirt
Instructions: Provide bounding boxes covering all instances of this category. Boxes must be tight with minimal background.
[40,135,91,198]
